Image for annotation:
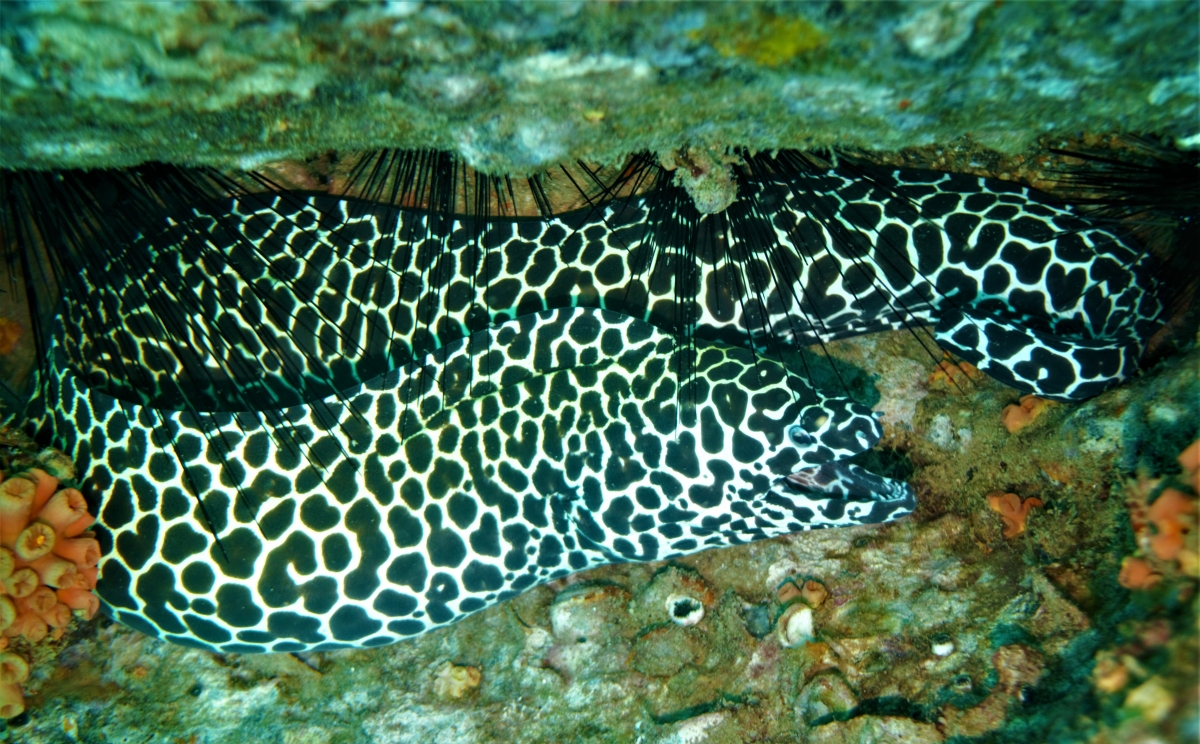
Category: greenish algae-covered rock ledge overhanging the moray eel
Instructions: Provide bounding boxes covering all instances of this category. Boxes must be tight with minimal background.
[0,0,1200,173]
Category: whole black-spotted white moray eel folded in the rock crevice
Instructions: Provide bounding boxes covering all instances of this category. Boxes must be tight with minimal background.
[4,152,1159,652]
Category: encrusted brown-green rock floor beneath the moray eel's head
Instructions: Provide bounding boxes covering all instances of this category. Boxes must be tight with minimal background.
[4,321,1200,744]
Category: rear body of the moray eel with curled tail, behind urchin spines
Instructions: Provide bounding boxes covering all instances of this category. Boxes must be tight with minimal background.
[68,164,1162,410]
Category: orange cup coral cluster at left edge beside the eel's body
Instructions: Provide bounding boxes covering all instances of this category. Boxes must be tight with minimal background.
[0,468,100,718]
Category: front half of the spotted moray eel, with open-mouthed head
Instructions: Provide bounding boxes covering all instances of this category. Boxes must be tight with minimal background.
[42,308,916,652]
